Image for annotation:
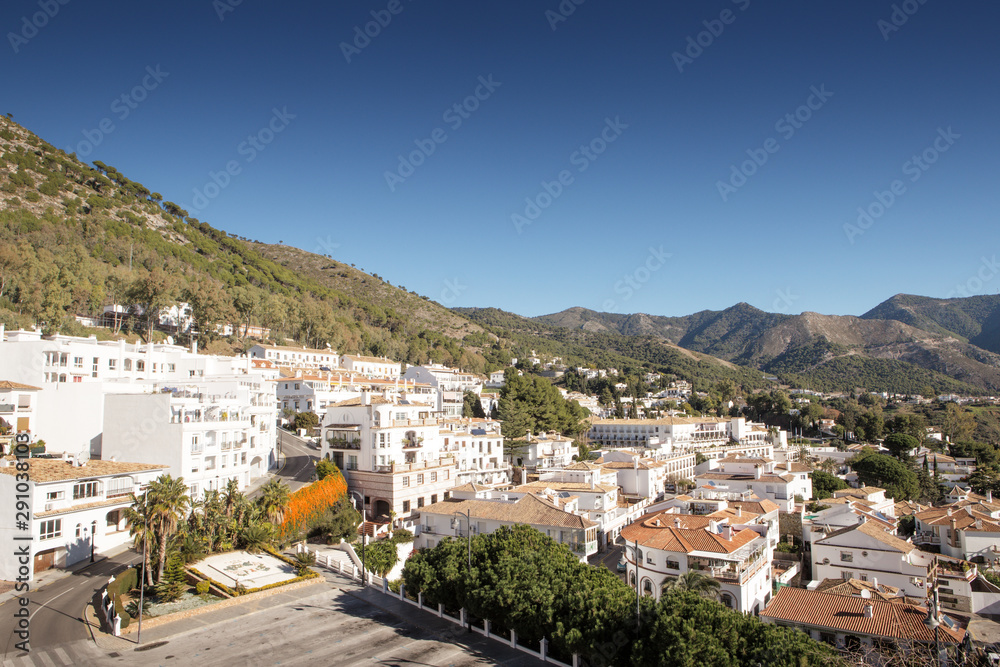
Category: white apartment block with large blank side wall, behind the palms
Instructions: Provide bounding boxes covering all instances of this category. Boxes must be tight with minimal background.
[102,375,277,498]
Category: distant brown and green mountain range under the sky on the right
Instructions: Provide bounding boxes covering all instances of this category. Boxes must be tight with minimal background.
[534,294,1000,393]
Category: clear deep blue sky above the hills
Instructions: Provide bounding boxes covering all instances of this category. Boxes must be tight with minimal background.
[0,0,1000,315]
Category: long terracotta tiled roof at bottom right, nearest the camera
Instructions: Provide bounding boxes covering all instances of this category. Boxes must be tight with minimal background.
[760,586,965,643]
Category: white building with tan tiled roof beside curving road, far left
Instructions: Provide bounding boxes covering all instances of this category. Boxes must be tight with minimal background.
[0,457,166,581]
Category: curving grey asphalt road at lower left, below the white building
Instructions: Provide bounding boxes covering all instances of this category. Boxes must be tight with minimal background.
[0,551,141,656]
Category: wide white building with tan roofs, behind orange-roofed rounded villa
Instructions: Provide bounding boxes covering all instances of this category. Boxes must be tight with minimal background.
[695,456,812,512]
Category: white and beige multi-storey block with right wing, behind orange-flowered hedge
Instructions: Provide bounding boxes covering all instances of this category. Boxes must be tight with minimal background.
[320,391,494,525]
